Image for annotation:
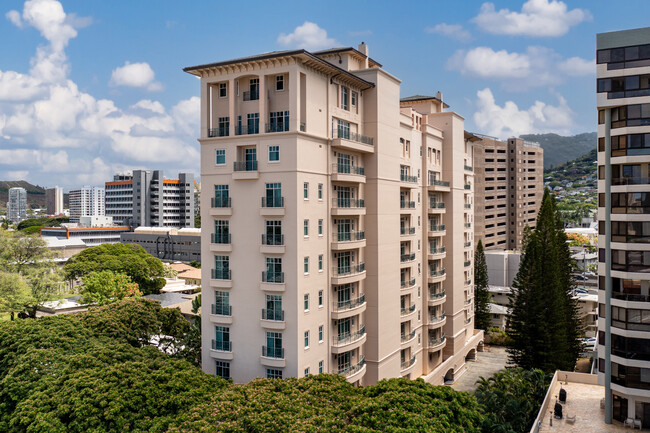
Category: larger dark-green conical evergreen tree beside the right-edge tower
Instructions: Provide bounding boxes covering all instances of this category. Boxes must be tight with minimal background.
[508,189,581,371]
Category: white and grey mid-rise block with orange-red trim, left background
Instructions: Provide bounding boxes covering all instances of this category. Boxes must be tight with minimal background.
[106,170,194,227]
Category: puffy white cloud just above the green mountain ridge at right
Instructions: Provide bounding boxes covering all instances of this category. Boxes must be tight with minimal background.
[474,88,573,139]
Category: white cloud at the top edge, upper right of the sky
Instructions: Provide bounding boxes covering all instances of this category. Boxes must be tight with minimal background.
[472,0,591,37]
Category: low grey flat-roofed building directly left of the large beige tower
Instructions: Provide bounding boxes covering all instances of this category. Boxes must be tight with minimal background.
[120,227,201,262]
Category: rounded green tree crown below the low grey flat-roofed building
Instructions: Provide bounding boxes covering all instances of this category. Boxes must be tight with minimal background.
[63,243,165,295]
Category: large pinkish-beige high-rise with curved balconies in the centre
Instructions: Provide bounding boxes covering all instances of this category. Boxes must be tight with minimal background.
[185,44,483,385]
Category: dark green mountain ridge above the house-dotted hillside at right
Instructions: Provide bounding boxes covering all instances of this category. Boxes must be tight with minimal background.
[519,132,597,169]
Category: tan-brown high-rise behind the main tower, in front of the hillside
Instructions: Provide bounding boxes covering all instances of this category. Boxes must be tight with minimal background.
[473,135,544,250]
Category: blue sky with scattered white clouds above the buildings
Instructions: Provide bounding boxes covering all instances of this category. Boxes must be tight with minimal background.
[0,0,650,190]
